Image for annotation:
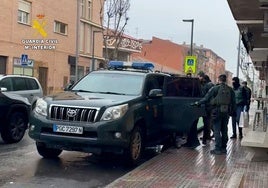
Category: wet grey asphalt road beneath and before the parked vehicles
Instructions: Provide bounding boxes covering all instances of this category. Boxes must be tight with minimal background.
[0,131,157,188]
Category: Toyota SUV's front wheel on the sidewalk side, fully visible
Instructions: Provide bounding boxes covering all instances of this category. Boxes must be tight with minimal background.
[125,126,144,165]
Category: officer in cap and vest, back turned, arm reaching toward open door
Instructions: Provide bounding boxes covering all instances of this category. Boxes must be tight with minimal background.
[192,74,235,155]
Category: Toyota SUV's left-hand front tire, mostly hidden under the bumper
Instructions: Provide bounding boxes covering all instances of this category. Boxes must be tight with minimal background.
[36,142,62,158]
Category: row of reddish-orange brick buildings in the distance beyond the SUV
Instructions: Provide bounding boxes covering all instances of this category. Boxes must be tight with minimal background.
[132,37,229,83]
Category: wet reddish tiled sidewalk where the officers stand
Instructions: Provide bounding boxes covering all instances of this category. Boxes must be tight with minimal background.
[106,102,268,188]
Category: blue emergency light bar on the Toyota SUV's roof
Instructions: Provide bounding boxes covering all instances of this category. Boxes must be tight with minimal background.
[108,61,154,70]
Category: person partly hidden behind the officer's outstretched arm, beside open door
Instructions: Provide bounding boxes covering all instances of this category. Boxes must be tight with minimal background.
[198,72,214,145]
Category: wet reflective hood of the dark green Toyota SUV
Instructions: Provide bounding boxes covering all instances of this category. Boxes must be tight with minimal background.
[45,91,140,107]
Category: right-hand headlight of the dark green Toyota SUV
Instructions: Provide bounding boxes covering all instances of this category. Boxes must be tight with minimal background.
[101,104,128,121]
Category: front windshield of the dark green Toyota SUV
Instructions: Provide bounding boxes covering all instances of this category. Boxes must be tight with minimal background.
[72,73,144,95]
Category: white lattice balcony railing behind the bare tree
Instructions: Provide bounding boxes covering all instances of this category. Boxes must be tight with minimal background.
[106,36,142,51]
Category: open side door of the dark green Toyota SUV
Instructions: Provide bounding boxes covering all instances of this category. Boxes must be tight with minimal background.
[162,76,206,133]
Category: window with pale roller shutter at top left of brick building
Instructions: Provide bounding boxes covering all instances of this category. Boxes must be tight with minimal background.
[18,0,31,24]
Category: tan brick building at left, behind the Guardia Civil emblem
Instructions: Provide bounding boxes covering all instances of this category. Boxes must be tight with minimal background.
[0,0,103,94]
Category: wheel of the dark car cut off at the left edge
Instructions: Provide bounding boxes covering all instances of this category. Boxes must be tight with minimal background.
[1,112,28,143]
